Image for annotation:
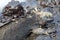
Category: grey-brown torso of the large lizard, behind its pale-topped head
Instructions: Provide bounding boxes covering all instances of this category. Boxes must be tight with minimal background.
[0,19,35,40]
